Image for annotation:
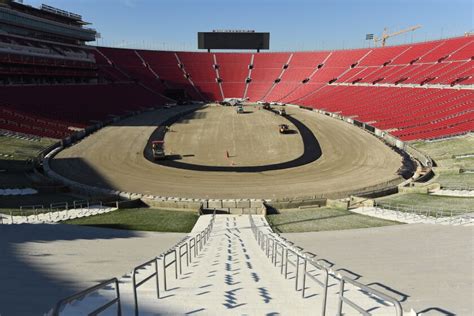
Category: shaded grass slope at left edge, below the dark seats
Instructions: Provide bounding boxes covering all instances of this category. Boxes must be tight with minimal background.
[0,136,57,160]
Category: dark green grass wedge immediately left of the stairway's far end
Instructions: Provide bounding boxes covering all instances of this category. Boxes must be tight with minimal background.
[65,208,199,233]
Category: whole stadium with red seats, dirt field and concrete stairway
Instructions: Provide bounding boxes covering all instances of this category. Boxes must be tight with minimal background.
[0,0,474,316]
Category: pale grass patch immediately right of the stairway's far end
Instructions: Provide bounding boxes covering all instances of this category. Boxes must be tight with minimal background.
[267,208,400,233]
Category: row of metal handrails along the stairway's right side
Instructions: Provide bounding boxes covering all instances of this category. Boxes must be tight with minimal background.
[249,215,403,316]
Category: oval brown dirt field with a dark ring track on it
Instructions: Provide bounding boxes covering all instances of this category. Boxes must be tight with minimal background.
[51,106,402,199]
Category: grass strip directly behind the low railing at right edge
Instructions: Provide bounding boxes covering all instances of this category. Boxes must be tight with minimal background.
[376,193,474,215]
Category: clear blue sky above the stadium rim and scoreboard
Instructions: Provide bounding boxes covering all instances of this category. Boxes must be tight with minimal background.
[24,0,474,51]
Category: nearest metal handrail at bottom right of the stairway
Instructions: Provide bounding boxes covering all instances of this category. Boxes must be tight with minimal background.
[336,276,403,316]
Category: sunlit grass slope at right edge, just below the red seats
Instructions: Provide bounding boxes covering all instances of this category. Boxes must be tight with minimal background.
[412,134,474,188]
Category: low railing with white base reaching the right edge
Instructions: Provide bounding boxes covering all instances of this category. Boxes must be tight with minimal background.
[373,202,474,225]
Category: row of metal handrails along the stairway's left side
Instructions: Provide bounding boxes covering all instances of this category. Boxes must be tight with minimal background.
[53,213,216,316]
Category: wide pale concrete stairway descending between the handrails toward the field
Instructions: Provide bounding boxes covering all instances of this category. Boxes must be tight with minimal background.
[50,215,412,315]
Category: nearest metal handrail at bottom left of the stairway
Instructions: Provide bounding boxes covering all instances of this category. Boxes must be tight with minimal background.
[52,278,122,316]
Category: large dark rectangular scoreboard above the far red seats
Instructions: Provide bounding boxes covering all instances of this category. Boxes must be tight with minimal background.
[198,30,270,50]
